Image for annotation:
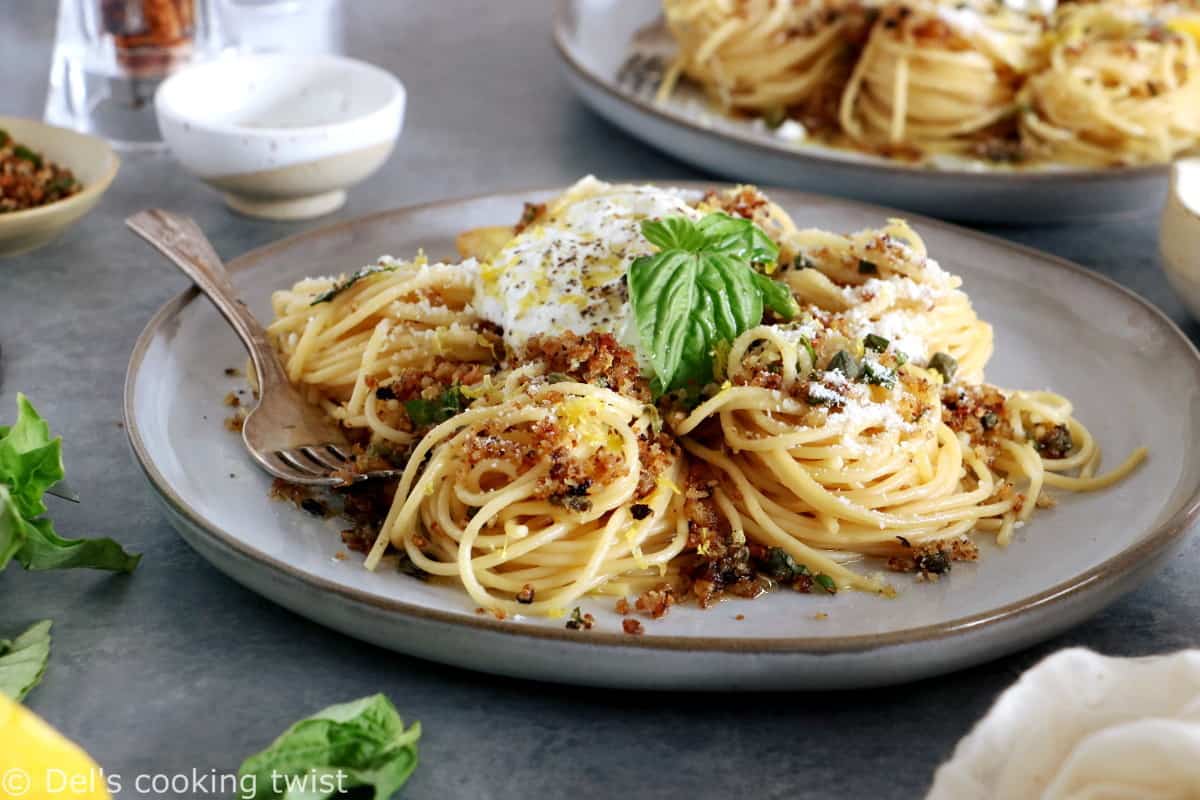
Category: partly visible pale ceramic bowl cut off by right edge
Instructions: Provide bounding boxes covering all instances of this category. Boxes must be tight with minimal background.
[1158,158,1200,319]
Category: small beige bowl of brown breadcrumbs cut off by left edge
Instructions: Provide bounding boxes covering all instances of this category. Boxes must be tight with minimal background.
[0,116,120,258]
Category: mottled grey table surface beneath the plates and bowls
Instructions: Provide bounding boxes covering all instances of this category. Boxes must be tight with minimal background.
[0,0,1200,799]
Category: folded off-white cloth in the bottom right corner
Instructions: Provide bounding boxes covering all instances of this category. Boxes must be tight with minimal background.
[926,648,1200,800]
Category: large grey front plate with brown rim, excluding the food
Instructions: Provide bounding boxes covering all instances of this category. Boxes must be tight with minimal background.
[125,185,1200,690]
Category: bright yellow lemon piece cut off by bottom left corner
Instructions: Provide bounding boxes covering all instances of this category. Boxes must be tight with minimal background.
[0,692,112,800]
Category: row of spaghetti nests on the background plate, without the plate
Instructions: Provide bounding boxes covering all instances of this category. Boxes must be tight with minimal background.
[659,0,1200,167]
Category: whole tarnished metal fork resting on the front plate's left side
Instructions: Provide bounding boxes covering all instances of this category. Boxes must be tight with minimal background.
[125,209,400,486]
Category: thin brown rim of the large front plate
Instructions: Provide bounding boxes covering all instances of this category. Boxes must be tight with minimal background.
[122,183,1200,655]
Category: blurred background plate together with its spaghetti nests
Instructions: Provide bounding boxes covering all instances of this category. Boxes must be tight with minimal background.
[554,0,1200,223]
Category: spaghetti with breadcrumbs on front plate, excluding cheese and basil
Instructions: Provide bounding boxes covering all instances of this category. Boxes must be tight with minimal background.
[270,187,1145,615]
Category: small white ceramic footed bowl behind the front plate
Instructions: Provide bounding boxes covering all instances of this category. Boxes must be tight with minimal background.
[155,54,406,219]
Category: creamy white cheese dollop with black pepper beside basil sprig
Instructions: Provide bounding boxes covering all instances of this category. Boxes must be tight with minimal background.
[474,176,701,353]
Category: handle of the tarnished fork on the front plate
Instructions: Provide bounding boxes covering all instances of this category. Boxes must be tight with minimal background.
[125,209,288,393]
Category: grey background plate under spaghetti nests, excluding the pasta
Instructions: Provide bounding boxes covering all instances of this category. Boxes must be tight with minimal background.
[554,0,1168,223]
